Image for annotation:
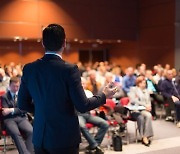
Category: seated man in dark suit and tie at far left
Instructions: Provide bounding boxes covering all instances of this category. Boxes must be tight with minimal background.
[2,77,34,154]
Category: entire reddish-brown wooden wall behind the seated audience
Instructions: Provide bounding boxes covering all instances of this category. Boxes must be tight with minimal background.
[0,0,175,68]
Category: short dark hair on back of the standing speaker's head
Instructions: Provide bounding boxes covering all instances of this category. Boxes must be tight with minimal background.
[42,24,66,51]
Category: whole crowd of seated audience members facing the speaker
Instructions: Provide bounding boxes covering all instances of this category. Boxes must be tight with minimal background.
[0,61,180,153]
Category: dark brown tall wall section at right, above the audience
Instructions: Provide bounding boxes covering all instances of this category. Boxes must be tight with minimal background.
[138,0,175,66]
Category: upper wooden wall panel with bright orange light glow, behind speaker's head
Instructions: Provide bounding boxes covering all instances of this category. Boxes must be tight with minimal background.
[0,0,137,40]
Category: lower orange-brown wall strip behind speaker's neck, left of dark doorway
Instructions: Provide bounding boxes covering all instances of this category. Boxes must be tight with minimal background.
[0,41,79,65]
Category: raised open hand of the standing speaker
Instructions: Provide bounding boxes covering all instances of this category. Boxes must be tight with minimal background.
[103,82,118,98]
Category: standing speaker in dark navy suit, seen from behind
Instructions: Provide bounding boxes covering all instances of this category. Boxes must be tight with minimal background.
[18,24,116,154]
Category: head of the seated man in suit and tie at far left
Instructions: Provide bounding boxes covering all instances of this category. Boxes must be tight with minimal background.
[9,77,20,93]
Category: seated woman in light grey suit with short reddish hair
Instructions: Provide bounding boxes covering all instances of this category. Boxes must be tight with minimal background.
[128,76,153,146]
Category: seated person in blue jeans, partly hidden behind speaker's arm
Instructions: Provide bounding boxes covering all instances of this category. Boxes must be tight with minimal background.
[78,78,109,154]
